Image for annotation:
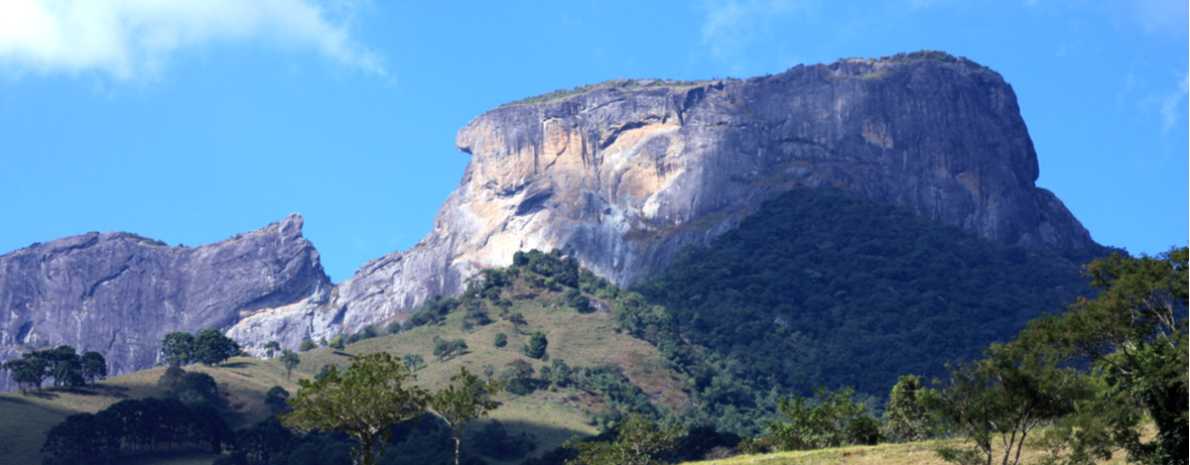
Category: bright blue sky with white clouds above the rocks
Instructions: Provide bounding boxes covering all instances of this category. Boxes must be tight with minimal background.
[0,0,1190,281]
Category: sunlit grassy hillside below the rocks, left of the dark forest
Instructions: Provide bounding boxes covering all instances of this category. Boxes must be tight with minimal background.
[0,261,689,465]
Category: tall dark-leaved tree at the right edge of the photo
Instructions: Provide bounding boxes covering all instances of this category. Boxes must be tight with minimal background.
[1019,247,1190,464]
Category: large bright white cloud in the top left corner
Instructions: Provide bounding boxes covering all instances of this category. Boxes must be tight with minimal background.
[0,0,384,81]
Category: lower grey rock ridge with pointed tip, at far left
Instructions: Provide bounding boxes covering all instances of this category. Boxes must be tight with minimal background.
[0,215,331,390]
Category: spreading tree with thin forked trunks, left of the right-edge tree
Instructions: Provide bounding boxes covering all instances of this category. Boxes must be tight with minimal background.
[938,345,1091,465]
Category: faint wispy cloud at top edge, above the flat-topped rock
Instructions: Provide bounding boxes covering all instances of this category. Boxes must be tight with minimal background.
[702,0,815,65]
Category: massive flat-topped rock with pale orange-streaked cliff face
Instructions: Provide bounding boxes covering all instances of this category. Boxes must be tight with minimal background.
[321,57,1098,331]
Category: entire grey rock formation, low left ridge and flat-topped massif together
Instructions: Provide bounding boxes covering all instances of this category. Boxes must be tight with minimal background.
[0,52,1100,388]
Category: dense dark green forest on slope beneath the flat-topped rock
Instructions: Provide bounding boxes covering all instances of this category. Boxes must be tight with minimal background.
[619,188,1108,434]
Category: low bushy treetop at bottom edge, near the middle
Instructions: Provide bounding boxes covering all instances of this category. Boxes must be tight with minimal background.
[563,414,683,465]
